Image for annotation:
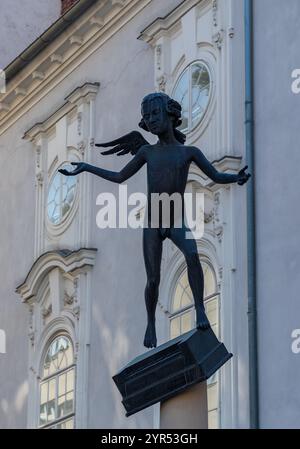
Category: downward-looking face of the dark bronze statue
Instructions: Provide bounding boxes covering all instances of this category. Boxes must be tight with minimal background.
[142,98,171,136]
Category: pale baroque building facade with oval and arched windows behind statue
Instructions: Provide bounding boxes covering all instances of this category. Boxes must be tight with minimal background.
[0,0,300,428]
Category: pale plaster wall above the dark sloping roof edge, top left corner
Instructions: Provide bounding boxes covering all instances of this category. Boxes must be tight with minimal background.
[0,0,61,69]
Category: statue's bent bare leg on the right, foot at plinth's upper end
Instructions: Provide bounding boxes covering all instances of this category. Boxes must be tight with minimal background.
[170,227,210,329]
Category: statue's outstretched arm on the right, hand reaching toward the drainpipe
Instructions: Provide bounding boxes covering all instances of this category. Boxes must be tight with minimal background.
[191,147,251,185]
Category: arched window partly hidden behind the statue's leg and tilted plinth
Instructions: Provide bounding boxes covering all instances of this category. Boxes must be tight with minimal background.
[170,261,220,429]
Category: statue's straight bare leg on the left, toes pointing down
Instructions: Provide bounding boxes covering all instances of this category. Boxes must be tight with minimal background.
[143,228,162,348]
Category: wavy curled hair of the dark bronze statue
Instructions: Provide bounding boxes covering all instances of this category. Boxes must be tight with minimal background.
[139,92,186,143]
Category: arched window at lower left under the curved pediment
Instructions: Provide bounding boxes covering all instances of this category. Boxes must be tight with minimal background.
[39,335,75,429]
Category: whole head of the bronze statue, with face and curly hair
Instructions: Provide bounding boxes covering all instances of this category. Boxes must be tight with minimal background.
[139,92,186,143]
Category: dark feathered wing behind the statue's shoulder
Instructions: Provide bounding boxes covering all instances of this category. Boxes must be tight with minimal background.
[95,131,149,156]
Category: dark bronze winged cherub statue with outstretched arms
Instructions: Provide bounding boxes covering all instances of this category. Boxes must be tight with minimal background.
[60,93,250,348]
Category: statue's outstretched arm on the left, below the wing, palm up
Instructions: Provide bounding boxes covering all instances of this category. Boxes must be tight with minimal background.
[59,148,146,184]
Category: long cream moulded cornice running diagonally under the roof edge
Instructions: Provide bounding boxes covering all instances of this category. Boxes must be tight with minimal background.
[0,0,151,135]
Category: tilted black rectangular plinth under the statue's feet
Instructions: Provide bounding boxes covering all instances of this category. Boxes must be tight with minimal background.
[113,329,232,416]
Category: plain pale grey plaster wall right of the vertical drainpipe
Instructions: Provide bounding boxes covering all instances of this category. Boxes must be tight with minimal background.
[254,0,300,428]
